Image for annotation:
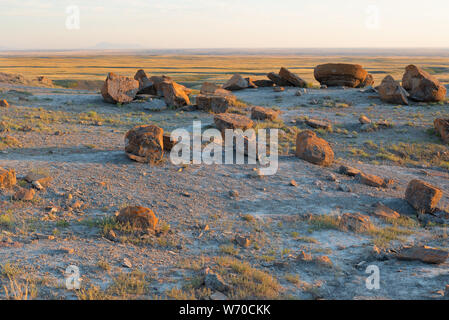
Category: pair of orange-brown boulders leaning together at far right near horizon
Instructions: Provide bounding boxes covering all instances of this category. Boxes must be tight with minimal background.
[376,65,447,105]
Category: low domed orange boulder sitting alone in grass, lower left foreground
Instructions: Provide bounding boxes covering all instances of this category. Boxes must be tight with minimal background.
[116,207,159,230]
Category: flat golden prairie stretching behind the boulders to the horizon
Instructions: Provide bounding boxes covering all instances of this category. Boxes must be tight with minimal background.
[0,54,449,89]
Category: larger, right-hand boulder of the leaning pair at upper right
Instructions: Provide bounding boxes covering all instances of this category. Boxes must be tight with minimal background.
[402,65,446,102]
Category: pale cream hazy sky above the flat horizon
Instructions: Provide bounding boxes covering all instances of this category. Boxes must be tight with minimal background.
[0,0,449,50]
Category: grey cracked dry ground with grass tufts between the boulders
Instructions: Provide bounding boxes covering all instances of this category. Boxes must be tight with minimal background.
[0,85,449,299]
